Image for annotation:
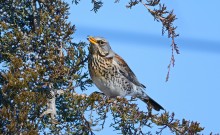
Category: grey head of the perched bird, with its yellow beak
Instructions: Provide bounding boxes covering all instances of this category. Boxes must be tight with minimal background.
[87,36,115,58]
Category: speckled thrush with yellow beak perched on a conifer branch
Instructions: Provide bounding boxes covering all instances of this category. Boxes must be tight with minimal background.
[87,36,164,111]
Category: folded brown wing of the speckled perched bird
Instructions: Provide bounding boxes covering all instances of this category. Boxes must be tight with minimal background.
[114,54,146,88]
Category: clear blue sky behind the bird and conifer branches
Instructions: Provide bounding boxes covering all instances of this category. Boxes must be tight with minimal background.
[69,0,220,134]
